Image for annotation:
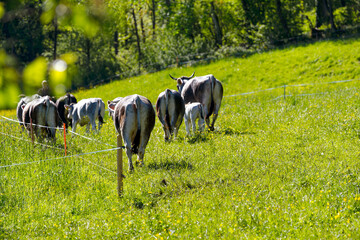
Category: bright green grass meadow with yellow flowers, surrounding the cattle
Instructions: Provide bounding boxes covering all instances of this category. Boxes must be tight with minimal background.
[0,39,360,239]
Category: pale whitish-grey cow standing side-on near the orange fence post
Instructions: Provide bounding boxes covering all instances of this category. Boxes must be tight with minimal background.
[65,98,105,132]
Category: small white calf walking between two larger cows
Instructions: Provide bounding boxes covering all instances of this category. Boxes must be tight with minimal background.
[184,102,205,136]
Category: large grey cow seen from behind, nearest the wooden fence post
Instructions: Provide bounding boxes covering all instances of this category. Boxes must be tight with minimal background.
[108,94,155,172]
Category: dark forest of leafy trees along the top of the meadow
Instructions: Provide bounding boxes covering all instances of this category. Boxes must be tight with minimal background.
[0,0,360,107]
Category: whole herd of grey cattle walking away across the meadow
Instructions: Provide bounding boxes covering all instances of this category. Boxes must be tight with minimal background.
[16,72,223,171]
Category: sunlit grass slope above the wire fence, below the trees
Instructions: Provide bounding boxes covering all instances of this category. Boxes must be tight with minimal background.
[76,39,360,102]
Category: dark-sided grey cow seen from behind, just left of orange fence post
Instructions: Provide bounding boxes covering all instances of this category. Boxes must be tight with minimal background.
[22,96,61,140]
